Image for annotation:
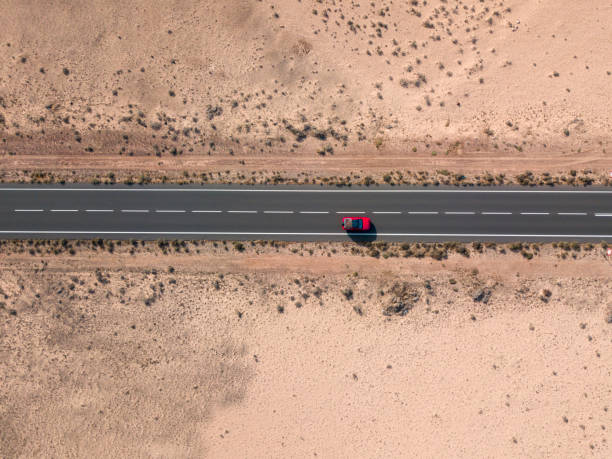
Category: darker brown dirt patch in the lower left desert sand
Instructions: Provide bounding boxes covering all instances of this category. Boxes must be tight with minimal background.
[0,266,253,457]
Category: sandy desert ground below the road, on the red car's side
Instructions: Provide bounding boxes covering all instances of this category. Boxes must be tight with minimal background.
[0,243,612,458]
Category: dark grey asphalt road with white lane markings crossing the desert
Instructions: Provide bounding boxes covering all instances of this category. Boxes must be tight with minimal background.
[0,185,612,241]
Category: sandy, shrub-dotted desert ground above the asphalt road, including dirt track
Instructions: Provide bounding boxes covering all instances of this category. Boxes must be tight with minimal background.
[0,0,612,180]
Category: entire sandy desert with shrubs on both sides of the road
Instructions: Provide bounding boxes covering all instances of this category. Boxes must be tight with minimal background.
[0,0,612,458]
